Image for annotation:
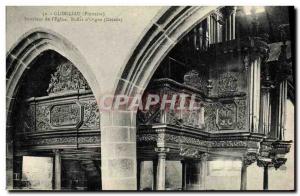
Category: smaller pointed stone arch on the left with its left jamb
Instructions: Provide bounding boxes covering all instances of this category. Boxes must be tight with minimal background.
[6,28,100,189]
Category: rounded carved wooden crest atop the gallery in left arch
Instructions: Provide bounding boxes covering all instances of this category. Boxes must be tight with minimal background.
[47,62,89,94]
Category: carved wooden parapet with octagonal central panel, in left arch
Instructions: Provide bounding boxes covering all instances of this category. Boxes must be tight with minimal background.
[22,95,100,132]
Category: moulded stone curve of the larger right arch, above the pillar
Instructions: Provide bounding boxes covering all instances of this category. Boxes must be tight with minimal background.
[115,6,217,101]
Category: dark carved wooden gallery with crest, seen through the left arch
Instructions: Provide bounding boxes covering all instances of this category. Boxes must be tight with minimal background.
[15,62,100,152]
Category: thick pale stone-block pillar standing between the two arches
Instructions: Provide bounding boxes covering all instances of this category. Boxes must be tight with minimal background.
[101,111,137,190]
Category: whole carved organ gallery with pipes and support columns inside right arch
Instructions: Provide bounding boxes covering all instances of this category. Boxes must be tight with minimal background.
[137,18,292,190]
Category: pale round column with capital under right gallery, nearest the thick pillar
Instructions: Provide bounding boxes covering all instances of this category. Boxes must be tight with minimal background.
[155,148,169,190]
